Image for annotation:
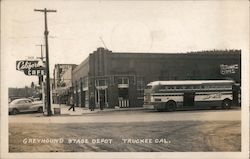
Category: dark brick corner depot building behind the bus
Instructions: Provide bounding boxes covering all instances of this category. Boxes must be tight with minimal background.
[71,48,241,108]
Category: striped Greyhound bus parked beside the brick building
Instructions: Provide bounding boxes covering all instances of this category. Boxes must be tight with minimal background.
[144,80,235,111]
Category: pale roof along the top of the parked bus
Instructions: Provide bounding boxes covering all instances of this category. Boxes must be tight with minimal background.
[148,80,234,86]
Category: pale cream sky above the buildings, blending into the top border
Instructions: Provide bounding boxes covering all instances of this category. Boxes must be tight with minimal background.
[1,0,249,87]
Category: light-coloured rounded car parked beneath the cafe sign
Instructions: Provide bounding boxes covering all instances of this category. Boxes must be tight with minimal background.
[9,98,43,115]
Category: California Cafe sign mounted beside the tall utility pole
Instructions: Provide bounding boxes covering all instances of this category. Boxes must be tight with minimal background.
[16,60,45,76]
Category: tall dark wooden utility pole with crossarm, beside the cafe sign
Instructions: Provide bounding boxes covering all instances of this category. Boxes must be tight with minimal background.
[34,8,56,116]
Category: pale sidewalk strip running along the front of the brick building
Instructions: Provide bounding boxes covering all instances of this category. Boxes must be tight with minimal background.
[48,104,144,116]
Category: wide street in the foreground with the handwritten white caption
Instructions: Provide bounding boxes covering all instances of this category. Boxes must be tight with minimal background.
[9,107,241,152]
